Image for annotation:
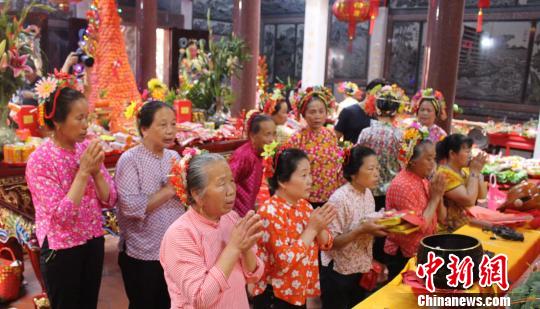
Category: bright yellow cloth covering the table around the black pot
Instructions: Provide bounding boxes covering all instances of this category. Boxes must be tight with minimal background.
[354,225,540,309]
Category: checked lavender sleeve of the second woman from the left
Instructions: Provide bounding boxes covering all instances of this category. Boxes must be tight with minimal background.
[115,153,149,220]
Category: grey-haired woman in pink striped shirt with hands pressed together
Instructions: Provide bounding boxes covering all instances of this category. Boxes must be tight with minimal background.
[160,154,264,309]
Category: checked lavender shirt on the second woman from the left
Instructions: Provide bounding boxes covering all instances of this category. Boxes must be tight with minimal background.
[115,145,185,261]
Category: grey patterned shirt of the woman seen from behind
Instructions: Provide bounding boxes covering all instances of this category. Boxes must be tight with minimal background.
[358,120,403,196]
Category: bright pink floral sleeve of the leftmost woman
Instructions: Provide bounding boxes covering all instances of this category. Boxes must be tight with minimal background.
[26,158,80,225]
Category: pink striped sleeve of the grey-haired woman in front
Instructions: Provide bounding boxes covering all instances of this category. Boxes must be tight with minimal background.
[160,229,230,308]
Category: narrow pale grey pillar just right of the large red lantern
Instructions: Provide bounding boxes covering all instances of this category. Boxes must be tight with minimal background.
[366,7,388,83]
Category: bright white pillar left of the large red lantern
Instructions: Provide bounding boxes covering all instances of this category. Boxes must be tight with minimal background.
[302,0,330,88]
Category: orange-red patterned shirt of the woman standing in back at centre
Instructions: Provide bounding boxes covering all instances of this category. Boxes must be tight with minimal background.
[284,127,345,203]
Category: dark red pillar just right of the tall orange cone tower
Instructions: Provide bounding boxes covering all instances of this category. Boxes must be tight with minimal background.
[135,0,157,89]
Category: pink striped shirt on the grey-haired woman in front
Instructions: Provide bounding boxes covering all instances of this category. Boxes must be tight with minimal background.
[160,208,264,309]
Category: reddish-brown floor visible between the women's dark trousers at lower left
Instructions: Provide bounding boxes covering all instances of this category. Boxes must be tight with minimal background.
[5,236,321,309]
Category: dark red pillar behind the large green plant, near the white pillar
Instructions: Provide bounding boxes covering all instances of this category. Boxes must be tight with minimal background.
[232,0,261,116]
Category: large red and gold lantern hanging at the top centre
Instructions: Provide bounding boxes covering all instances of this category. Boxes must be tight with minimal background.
[332,0,380,41]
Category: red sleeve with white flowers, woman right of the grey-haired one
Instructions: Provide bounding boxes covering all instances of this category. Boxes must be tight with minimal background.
[257,205,308,273]
